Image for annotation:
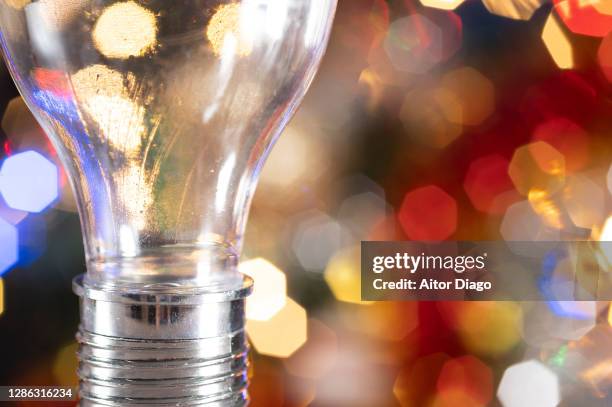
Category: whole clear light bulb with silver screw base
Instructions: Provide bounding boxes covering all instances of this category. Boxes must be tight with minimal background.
[0,0,336,406]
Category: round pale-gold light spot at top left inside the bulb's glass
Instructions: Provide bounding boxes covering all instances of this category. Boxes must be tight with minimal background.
[93,1,157,59]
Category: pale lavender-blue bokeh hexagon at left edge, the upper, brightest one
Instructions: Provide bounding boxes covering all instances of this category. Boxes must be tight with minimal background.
[0,151,58,213]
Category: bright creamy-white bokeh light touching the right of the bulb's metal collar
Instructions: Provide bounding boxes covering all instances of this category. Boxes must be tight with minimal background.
[238,258,287,321]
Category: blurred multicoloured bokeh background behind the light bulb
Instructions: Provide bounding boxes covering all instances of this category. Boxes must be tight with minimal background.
[0,0,612,407]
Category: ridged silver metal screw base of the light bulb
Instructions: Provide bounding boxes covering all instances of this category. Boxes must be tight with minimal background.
[73,276,252,407]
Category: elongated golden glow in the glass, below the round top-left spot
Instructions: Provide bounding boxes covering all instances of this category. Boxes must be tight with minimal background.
[71,65,145,152]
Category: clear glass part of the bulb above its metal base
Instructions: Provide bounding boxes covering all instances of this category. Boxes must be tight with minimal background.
[0,0,336,290]
